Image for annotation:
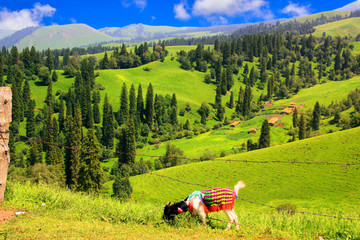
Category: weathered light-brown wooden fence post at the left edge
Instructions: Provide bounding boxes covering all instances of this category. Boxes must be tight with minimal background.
[0,87,12,204]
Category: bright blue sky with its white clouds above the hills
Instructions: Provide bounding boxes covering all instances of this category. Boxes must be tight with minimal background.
[0,0,360,30]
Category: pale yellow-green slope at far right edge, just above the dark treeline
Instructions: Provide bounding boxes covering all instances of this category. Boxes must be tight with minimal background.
[313,18,360,38]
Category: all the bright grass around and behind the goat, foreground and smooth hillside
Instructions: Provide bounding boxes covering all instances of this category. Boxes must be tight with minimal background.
[0,128,360,239]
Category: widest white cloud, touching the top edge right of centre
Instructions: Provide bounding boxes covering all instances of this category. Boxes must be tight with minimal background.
[192,0,268,17]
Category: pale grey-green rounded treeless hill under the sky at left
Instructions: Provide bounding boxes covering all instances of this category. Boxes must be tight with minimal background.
[16,24,119,50]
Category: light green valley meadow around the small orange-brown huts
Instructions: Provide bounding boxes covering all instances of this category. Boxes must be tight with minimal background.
[138,77,360,160]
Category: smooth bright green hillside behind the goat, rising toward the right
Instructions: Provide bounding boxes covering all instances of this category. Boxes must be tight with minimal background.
[131,128,360,239]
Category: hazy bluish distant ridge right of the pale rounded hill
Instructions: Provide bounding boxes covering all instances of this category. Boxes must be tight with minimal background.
[99,23,249,40]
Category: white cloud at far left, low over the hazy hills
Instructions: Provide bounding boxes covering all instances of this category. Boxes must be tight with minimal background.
[0,3,56,30]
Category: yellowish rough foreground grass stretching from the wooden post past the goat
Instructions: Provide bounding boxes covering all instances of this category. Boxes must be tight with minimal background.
[0,183,292,239]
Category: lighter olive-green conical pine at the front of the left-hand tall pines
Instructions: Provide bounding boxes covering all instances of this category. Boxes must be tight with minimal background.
[76,129,104,193]
